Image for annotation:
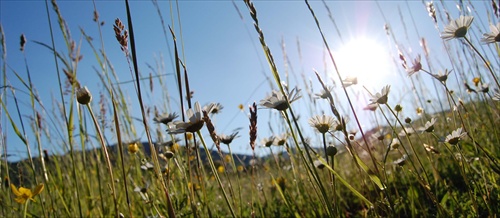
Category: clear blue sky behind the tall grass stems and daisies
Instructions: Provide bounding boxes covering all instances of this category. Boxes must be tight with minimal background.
[0,0,493,162]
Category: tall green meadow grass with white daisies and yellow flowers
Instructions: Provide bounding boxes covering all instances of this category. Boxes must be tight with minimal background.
[0,0,500,217]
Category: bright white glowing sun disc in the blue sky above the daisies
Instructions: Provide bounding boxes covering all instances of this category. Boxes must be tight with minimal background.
[333,38,392,87]
